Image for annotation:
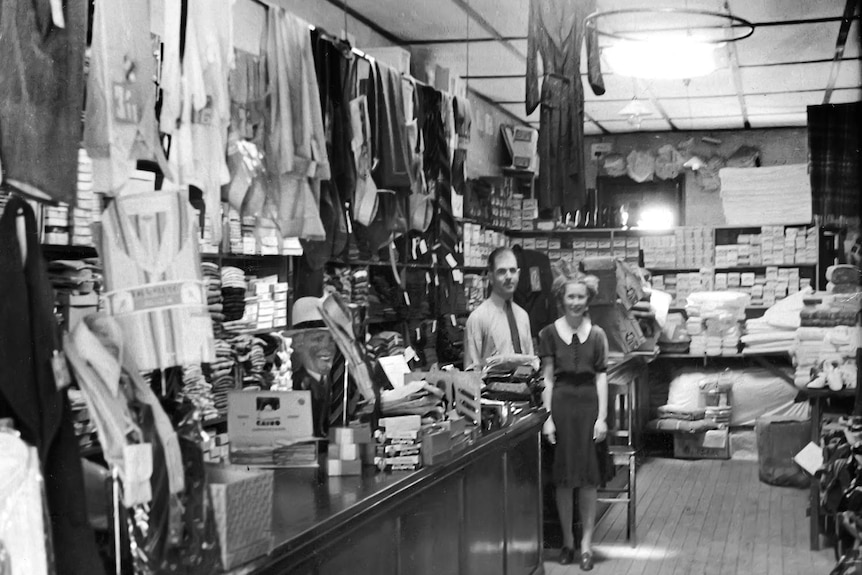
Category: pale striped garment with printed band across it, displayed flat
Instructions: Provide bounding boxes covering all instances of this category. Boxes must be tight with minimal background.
[99,188,215,370]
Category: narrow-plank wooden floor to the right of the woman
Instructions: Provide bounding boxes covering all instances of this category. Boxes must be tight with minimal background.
[545,458,835,575]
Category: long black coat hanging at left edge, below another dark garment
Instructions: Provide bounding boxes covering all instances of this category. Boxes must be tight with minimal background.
[0,196,104,575]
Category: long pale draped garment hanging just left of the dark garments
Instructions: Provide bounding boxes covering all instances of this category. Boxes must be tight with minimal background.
[264,7,330,240]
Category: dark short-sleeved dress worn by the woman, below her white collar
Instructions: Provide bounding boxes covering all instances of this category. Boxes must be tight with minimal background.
[539,324,613,487]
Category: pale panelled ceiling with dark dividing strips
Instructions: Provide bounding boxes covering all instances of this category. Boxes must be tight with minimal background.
[328,0,862,134]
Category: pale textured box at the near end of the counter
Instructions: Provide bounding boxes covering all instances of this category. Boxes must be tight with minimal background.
[206,464,273,570]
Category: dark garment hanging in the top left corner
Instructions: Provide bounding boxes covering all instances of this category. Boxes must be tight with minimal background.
[0,0,87,204]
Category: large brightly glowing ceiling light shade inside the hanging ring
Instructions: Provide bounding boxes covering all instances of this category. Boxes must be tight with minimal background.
[603,38,717,80]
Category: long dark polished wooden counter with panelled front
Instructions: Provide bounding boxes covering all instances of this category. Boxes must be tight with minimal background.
[235,410,547,575]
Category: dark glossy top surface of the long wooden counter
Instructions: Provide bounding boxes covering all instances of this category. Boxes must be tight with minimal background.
[230,410,547,575]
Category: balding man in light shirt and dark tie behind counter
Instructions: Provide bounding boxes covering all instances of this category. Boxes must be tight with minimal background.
[464,248,533,369]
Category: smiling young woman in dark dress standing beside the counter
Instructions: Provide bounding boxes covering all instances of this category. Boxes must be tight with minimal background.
[539,276,613,571]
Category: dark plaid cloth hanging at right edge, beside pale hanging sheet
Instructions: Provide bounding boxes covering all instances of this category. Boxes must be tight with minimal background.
[808,102,862,227]
